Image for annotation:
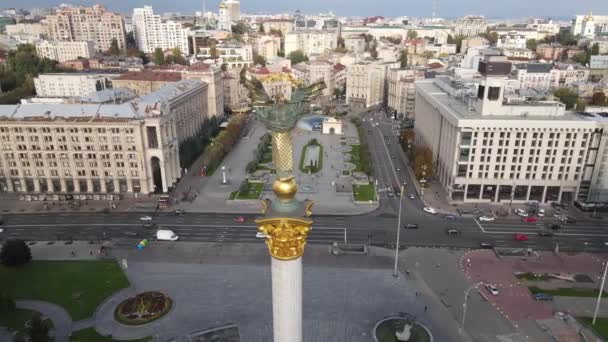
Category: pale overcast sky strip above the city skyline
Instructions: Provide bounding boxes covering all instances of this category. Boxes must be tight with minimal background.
[0,0,608,18]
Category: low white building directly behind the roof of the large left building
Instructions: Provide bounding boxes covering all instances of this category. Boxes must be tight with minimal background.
[34,73,120,97]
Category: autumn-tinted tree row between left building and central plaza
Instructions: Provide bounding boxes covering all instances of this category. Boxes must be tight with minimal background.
[203,114,245,172]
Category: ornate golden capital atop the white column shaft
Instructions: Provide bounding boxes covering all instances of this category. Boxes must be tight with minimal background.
[255,217,312,260]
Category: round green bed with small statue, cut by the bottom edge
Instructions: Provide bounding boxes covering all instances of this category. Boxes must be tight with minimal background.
[373,317,433,342]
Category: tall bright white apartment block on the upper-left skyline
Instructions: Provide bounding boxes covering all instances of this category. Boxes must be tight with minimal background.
[132,6,190,54]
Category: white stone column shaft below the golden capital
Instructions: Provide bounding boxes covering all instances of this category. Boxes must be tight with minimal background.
[271,257,302,342]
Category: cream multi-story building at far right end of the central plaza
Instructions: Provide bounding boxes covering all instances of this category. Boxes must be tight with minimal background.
[346,62,398,108]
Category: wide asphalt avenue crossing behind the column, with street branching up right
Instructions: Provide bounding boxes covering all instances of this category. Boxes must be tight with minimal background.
[0,114,608,252]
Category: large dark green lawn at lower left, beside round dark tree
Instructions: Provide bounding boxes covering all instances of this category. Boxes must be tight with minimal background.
[0,260,129,321]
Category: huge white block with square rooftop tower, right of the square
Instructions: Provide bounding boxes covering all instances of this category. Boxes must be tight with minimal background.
[415,57,601,203]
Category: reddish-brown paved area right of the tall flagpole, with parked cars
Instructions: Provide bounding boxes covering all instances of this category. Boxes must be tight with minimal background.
[460,250,603,323]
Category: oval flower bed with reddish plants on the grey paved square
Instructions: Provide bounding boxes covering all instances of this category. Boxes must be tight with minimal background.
[114,291,173,325]
